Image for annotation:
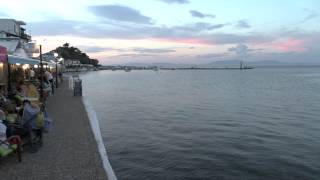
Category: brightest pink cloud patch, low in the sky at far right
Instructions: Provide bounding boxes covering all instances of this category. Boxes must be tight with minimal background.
[273,39,306,52]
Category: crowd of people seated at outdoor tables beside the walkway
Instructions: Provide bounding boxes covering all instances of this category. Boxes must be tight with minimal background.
[0,68,55,155]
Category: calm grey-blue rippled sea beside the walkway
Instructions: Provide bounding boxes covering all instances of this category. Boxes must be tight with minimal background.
[82,68,320,180]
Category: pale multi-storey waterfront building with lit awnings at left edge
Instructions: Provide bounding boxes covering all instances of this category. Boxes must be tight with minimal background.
[0,19,39,91]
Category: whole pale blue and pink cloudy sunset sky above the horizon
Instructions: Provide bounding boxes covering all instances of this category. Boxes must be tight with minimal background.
[0,0,320,64]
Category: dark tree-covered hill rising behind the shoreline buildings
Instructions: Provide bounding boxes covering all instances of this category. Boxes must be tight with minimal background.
[54,43,99,66]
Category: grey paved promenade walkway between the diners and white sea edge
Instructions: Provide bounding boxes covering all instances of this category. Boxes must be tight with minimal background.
[0,83,107,180]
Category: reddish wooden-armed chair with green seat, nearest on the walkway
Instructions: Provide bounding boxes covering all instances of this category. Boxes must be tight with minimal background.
[0,136,21,162]
